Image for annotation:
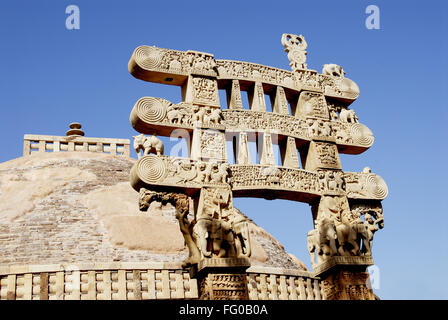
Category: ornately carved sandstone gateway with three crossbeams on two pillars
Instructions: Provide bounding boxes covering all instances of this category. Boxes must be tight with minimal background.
[128,34,388,299]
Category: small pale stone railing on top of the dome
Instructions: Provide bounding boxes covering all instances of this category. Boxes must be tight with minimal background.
[23,134,130,157]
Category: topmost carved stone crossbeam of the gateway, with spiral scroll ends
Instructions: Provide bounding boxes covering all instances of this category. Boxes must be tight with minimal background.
[128,46,359,105]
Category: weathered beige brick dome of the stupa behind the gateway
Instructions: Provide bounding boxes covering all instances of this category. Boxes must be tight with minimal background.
[0,152,306,270]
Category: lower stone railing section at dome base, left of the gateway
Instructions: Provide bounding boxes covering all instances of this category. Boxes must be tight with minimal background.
[0,263,198,300]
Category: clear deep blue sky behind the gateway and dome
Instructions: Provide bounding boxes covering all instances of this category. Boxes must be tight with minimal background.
[0,0,448,299]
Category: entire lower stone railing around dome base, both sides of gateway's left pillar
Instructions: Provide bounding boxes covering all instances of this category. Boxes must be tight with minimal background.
[0,262,322,300]
